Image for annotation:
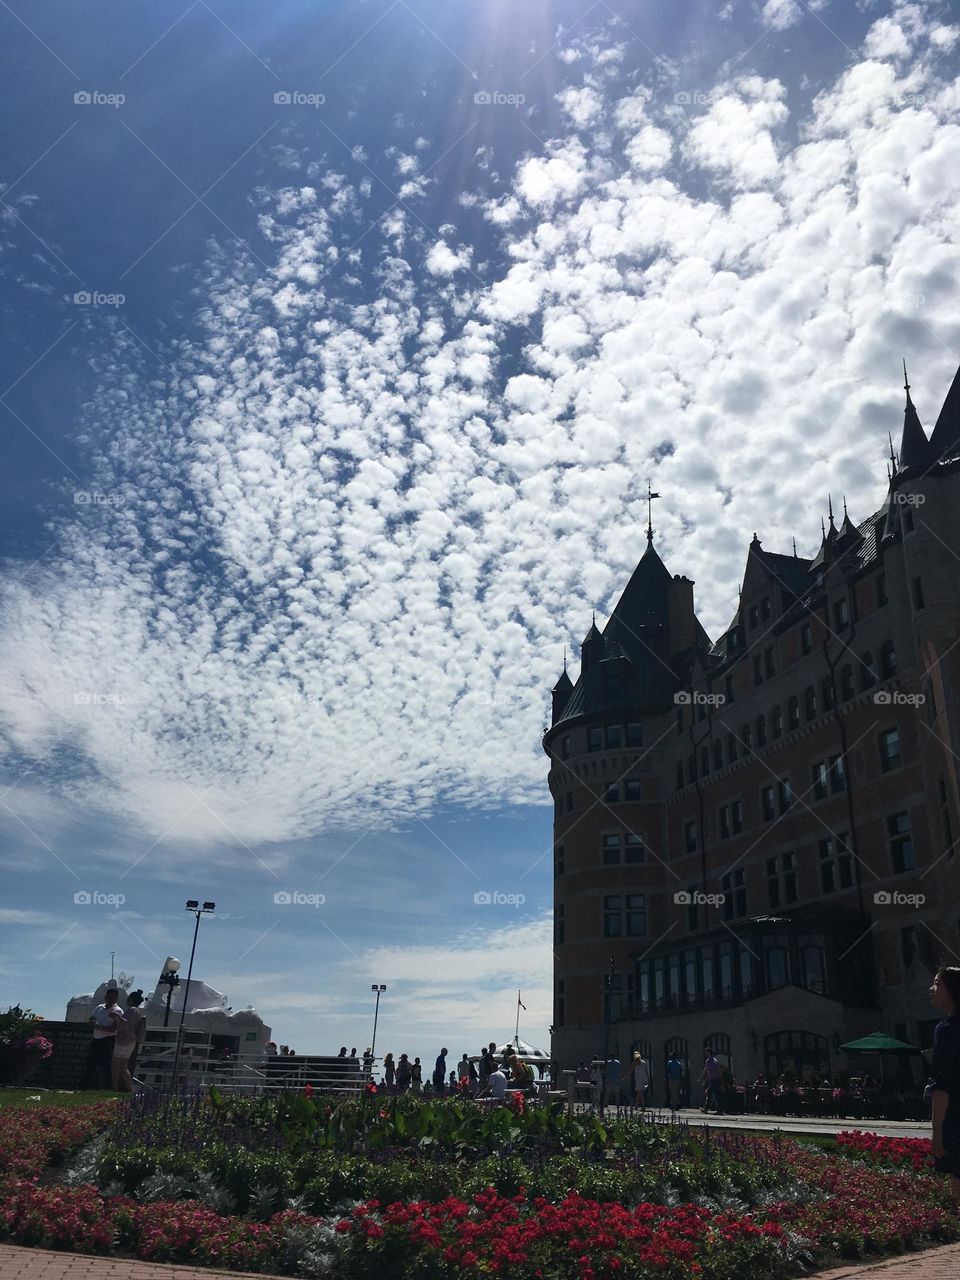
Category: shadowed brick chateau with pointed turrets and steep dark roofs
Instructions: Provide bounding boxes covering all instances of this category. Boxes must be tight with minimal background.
[543,371,960,1101]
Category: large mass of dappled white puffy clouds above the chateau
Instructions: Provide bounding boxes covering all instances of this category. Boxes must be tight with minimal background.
[0,0,960,841]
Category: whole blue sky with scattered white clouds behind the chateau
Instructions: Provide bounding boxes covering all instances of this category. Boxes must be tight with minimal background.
[0,0,960,1061]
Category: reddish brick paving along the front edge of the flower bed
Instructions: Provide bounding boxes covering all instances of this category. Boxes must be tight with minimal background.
[0,1244,960,1280]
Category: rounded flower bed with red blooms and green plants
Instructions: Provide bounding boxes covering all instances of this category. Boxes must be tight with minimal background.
[0,1097,960,1280]
